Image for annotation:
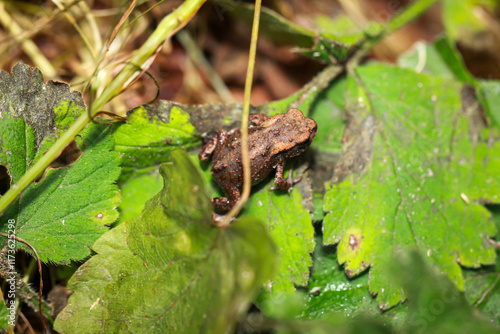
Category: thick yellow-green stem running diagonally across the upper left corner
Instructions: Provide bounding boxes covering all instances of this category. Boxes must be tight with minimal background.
[0,0,206,214]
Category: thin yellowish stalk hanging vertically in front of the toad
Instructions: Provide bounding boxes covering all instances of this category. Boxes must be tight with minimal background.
[221,0,262,226]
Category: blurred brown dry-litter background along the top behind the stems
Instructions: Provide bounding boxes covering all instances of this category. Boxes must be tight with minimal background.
[0,0,500,114]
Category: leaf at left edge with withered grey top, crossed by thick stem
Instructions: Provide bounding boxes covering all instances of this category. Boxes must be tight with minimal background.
[0,63,120,263]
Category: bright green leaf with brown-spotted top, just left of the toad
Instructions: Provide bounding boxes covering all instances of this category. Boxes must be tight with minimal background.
[113,101,200,223]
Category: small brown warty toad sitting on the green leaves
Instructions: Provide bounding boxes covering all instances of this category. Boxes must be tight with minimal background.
[199,109,318,212]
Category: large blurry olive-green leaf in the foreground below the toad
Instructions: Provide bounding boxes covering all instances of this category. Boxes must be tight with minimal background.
[55,151,275,333]
